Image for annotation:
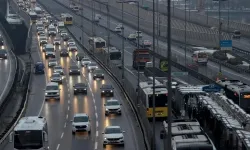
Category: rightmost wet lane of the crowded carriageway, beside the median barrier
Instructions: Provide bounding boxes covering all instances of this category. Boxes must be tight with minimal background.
[73,51,141,149]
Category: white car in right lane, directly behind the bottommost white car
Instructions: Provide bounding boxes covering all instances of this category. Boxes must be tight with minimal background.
[104,99,122,116]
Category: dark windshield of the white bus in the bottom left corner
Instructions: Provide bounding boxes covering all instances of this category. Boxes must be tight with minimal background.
[14,130,43,149]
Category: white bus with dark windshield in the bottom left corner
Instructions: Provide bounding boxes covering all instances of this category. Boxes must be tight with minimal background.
[9,116,49,150]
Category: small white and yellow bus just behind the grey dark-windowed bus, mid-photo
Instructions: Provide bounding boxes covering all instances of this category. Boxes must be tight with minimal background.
[89,37,107,52]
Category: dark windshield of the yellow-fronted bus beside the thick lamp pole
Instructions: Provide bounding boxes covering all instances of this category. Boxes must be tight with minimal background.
[148,94,168,108]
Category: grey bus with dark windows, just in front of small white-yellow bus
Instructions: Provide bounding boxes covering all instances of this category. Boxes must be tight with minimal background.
[103,47,122,68]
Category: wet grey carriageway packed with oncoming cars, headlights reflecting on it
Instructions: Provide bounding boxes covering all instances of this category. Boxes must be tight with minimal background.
[4,8,143,150]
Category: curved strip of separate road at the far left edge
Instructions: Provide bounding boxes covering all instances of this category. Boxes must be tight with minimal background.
[0,31,15,104]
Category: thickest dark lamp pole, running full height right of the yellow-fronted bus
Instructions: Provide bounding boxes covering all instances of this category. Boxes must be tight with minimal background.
[167,0,172,150]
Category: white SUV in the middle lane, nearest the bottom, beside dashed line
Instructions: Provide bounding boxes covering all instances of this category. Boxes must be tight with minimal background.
[71,113,91,134]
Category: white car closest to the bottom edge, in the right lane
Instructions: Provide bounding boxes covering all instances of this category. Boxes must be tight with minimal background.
[102,126,125,147]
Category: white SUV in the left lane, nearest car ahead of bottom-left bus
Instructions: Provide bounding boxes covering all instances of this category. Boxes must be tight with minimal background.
[45,82,60,100]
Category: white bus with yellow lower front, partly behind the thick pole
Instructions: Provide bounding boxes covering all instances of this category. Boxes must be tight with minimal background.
[138,80,168,120]
